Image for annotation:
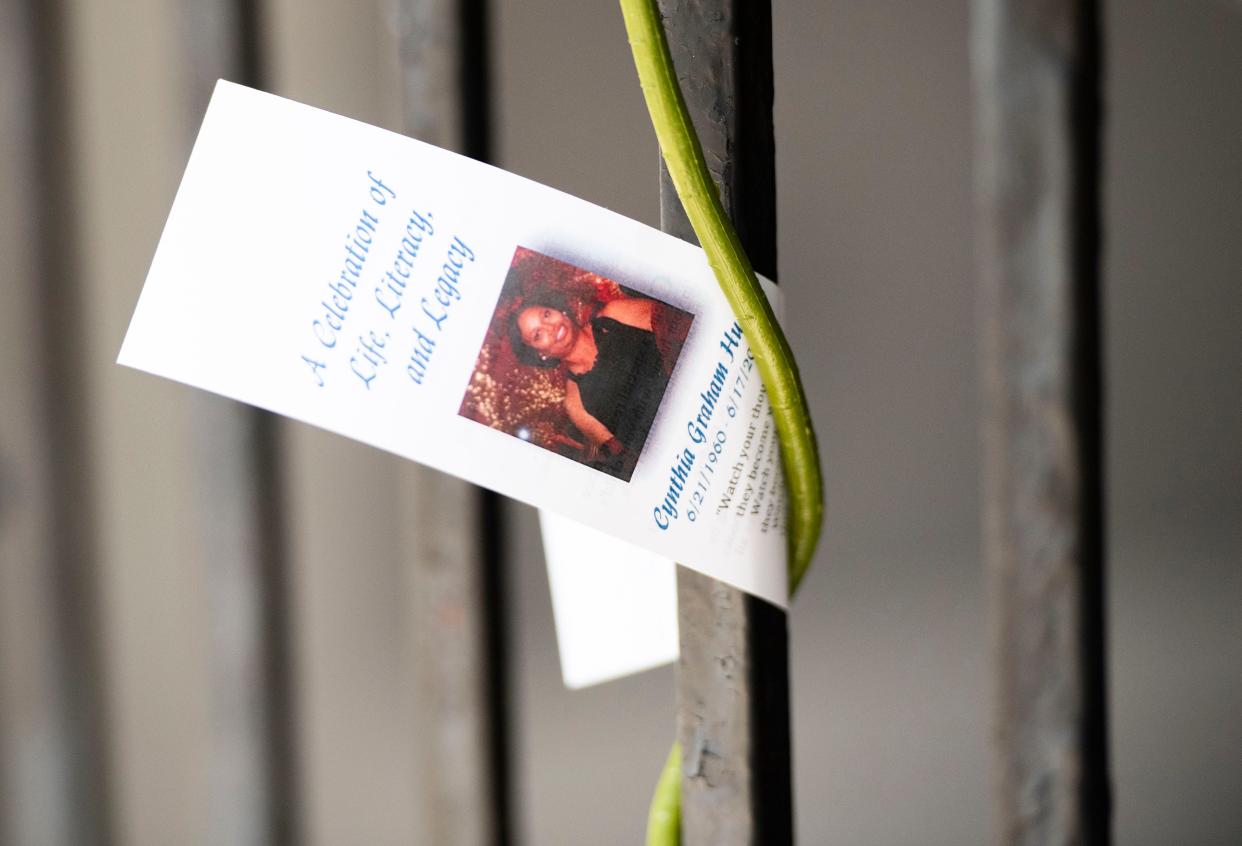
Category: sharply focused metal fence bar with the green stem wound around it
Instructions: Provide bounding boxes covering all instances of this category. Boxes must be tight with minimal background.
[661,0,792,846]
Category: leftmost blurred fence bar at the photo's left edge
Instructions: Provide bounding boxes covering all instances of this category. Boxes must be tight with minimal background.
[0,0,112,846]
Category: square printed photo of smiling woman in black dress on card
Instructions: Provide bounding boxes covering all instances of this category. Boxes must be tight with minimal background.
[460,247,694,481]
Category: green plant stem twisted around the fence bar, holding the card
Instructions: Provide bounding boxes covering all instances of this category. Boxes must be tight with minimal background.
[621,0,823,846]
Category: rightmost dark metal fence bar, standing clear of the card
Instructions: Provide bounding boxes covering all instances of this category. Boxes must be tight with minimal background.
[972,0,1110,846]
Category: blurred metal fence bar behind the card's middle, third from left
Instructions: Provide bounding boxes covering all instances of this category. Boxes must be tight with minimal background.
[396,0,510,846]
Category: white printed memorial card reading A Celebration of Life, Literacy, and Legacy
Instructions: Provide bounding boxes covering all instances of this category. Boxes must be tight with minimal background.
[119,82,787,606]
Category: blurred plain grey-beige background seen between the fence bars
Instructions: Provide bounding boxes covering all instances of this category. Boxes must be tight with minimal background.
[0,0,1242,846]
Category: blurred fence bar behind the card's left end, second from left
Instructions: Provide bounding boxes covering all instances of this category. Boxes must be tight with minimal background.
[175,0,299,846]
